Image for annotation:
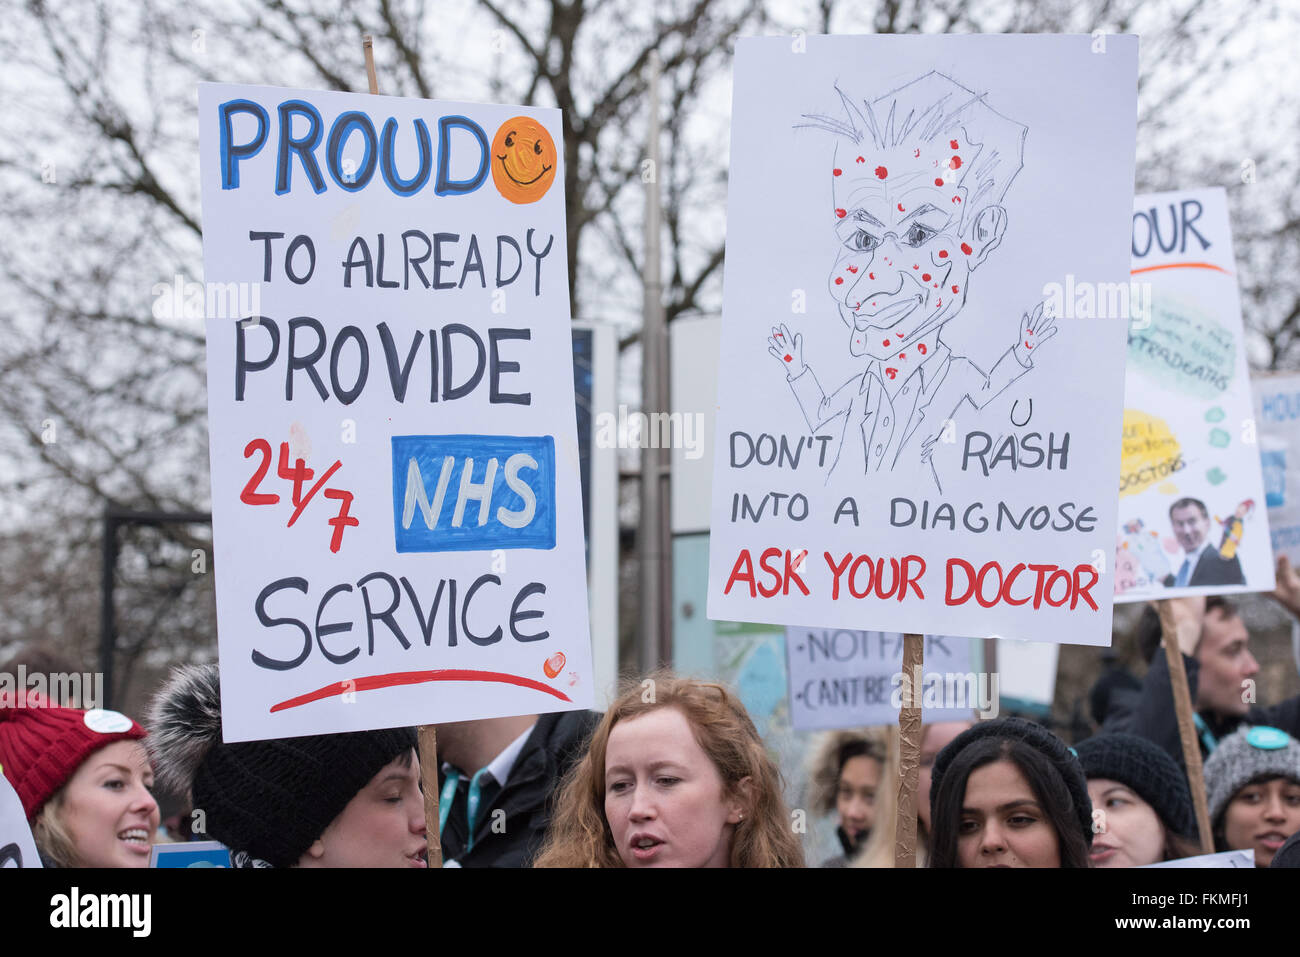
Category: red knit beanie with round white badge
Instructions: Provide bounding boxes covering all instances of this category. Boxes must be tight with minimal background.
[0,690,146,823]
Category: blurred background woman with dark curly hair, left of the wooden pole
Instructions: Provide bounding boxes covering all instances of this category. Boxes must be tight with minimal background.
[809,728,885,867]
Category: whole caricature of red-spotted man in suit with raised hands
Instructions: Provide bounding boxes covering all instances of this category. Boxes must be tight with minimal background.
[767,72,1057,490]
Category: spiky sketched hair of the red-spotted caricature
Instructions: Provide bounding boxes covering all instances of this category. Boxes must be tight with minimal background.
[796,70,1028,233]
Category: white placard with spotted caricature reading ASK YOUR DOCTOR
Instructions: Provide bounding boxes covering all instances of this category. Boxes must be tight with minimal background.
[709,36,1138,645]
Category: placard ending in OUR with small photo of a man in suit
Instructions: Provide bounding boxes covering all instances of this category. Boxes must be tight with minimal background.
[1115,189,1273,602]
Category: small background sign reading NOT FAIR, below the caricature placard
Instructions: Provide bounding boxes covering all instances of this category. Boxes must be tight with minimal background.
[785,628,977,731]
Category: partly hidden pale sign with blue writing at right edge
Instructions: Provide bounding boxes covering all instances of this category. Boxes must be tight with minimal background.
[1253,374,1300,567]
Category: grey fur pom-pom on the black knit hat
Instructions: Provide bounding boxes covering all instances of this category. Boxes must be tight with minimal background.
[146,664,221,794]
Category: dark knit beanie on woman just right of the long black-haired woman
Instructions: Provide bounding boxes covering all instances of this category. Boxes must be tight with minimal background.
[1074,733,1196,837]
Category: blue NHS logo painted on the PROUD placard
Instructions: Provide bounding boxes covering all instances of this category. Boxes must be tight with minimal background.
[393,436,555,551]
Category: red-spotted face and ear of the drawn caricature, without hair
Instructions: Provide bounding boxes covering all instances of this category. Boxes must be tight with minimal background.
[828,134,1006,359]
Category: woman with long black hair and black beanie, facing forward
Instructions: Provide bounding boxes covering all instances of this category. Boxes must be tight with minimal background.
[930,718,1092,867]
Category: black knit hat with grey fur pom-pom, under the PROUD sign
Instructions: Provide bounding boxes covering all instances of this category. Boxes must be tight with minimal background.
[146,664,416,867]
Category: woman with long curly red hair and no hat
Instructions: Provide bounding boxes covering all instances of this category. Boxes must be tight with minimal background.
[534,674,803,867]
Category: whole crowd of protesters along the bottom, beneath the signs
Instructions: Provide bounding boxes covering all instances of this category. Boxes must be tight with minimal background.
[0,582,1300,867]
